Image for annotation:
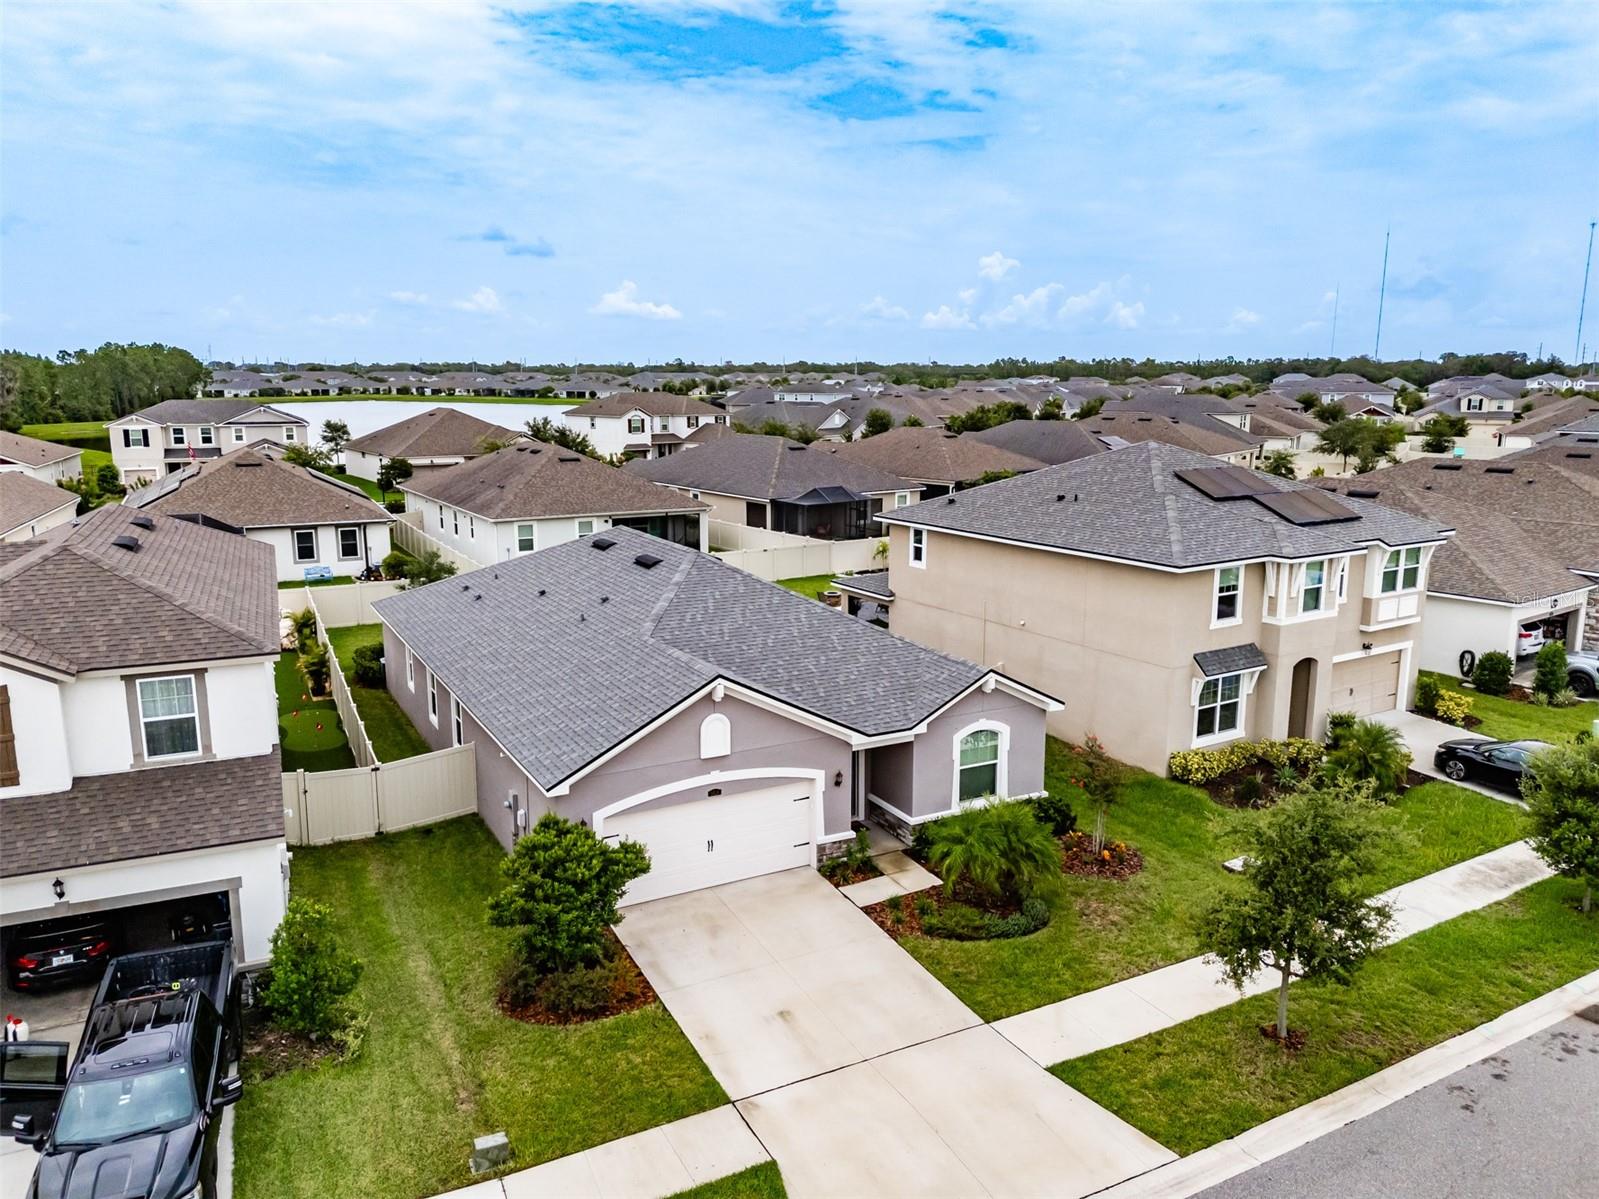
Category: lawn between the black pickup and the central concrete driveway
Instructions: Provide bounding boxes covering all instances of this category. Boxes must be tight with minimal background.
[233,817,728,1199]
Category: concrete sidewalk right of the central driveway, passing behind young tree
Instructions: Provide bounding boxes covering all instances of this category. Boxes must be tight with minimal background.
[993,841,1551,1066]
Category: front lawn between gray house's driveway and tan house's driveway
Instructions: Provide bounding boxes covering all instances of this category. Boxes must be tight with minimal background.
[900,737,1522,1020]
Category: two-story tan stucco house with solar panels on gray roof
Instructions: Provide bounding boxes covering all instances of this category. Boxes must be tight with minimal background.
[879,441,1450,771]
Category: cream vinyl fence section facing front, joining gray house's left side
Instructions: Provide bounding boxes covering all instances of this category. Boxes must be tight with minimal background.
[283,745,478,846]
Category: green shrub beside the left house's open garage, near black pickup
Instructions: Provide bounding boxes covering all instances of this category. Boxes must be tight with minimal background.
[261,898,361,1039]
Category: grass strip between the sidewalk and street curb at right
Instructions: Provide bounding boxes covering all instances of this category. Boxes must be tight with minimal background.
[1052,879,1599,1154]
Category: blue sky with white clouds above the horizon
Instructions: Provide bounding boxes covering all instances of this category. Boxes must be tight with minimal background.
[0,0,1599,361]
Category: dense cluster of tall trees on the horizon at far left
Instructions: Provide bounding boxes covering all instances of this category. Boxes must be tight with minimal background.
[0,342,211,432]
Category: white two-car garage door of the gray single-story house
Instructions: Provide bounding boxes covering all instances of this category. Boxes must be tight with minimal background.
[601,782,814,903]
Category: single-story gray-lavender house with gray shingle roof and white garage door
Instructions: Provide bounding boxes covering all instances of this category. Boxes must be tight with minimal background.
[374,529,1062,903]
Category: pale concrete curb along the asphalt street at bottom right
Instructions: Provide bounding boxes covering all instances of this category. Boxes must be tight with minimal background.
[1097,970,1599,1199]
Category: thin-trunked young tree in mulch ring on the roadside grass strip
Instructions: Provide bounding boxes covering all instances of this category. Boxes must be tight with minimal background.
[1201,777,1393,1039]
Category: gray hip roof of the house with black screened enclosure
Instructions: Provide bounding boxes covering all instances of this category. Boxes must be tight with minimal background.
[622,433,916,500]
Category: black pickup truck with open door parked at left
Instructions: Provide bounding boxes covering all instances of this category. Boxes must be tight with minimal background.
[0,942,241,1199]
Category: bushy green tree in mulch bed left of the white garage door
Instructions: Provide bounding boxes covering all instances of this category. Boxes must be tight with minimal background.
[489,812,649,974]
